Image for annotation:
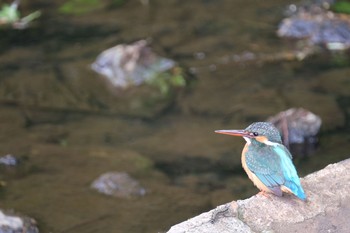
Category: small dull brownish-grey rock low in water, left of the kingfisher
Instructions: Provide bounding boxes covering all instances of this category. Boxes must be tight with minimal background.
[91,172,146,198]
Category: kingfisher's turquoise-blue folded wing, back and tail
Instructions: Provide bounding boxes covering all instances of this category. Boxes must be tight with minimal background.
[246,144,306,200]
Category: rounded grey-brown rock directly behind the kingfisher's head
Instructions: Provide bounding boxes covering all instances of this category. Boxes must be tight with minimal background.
[268,108,322,154]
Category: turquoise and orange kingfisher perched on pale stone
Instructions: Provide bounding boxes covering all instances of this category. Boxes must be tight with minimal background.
[215,122,306,201]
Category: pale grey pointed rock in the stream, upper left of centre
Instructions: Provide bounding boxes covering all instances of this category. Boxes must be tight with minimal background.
[91,40,175,88]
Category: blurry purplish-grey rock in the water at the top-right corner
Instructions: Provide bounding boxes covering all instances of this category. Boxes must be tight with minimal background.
[277,0,350,50]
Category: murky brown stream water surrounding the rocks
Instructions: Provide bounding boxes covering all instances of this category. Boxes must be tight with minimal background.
[0,0,350,233]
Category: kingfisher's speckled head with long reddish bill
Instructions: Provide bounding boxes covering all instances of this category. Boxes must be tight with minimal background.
[215,122,282,145]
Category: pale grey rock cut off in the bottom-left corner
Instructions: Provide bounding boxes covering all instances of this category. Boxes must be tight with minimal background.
[0,210,39,233]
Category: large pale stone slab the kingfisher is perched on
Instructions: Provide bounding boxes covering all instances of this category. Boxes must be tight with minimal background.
[168,159,350,233]
